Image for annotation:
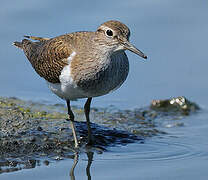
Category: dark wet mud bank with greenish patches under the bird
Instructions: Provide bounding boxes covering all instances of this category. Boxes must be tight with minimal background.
[0,97,199,173]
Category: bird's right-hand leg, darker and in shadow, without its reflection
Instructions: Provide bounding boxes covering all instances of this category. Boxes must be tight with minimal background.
[84,97,93,145]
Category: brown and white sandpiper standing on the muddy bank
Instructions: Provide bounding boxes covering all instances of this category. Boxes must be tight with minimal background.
[13,20,147,148]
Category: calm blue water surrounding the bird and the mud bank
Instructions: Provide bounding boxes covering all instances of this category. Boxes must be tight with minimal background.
[0,0,208,180]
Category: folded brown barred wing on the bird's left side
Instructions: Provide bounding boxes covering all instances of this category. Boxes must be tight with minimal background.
[22,34,73,83]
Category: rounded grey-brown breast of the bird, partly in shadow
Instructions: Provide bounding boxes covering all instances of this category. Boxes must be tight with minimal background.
[74,51,129,97]
